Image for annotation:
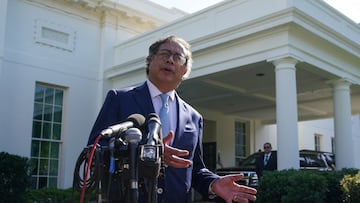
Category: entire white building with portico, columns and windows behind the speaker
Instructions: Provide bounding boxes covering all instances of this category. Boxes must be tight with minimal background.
[0,0,360,188]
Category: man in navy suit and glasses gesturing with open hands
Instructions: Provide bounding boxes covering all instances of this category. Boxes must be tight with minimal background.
[88,36,256,203]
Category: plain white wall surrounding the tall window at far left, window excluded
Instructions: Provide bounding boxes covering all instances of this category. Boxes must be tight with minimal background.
[0,0,183,188]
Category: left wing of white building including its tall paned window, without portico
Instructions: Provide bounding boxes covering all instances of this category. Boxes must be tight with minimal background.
[0,0,183,188]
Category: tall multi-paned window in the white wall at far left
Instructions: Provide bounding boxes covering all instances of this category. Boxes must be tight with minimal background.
[31,84,64,189]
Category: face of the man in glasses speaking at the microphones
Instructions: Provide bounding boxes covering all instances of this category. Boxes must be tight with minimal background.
[148,42,187,92]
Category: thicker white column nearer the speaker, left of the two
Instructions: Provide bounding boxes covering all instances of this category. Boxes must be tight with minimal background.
[273,57,300,170]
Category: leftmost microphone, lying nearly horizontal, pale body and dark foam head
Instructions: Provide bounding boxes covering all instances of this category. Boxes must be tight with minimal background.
[101,114,145,137]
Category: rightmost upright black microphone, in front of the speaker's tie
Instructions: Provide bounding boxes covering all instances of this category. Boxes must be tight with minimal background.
[147,113,162,145]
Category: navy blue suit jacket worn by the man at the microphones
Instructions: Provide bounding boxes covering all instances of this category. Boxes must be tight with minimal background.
[88,83,219,203]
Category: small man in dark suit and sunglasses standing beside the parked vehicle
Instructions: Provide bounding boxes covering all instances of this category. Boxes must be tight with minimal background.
[256,142,277,178]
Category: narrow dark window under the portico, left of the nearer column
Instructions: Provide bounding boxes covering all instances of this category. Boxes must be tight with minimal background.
[235,122,246,165]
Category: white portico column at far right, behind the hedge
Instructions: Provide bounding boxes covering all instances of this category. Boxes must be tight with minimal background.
[332,79,355,169]
